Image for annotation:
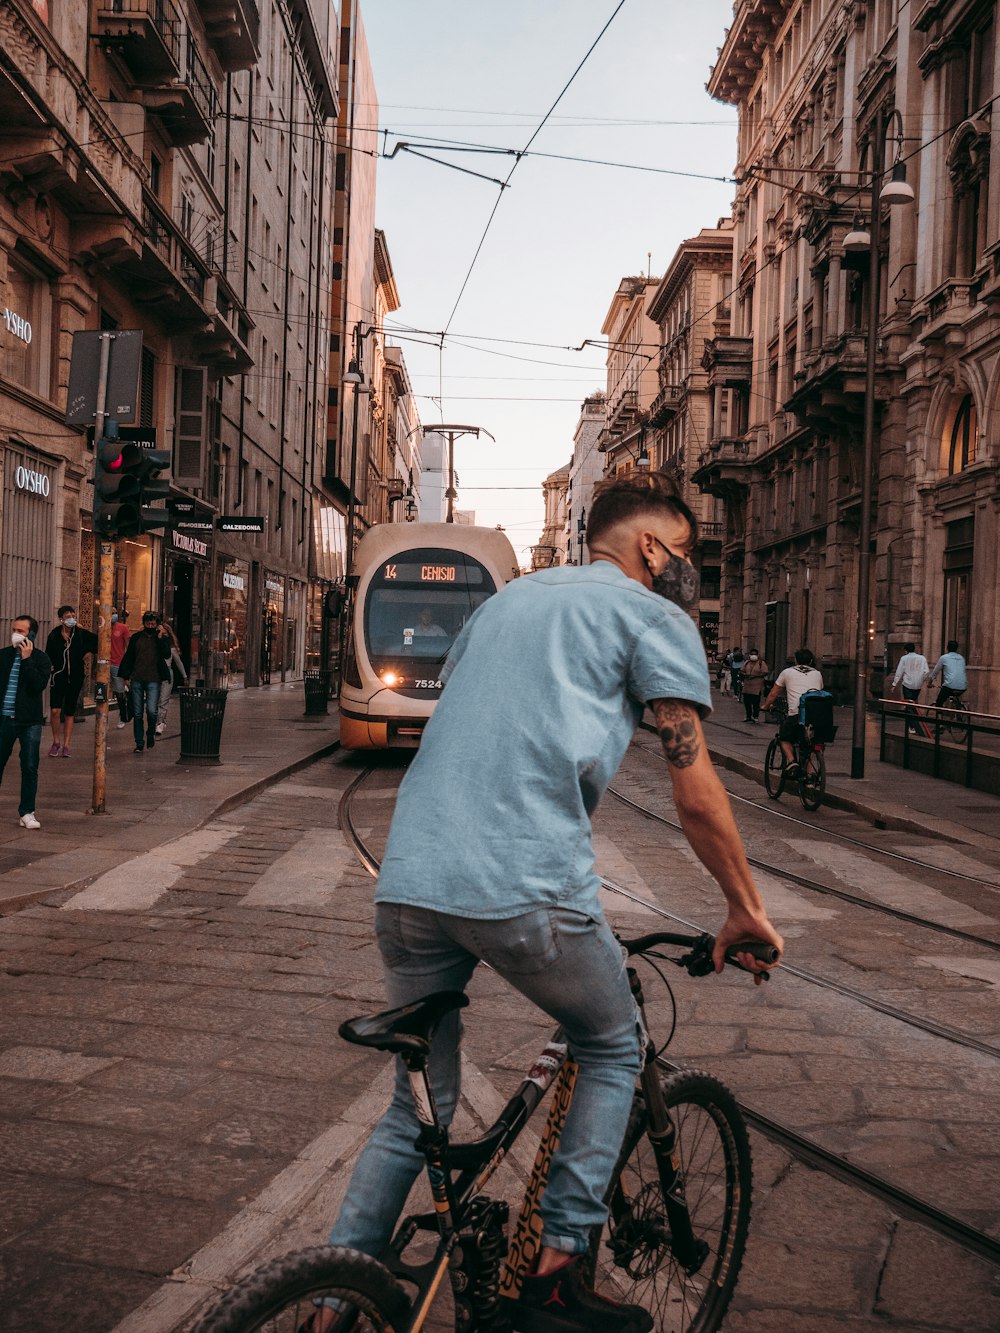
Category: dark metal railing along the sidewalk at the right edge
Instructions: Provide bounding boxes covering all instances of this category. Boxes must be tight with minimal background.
[877,698,1000,792]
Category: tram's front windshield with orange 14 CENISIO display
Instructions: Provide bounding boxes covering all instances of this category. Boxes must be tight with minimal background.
[364,548,496,670]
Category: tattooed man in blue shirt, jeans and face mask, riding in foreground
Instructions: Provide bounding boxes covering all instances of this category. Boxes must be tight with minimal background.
[325,476,781,1333]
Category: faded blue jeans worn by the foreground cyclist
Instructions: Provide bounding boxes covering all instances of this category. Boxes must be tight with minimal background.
[329,904,641,1256]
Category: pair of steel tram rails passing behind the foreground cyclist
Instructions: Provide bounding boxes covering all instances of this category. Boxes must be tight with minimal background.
[337,768,1000,1265]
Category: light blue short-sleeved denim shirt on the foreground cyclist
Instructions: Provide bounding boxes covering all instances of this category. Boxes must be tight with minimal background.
[375,561,711,920]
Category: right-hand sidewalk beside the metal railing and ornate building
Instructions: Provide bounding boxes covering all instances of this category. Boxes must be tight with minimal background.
[705,690,1000,846]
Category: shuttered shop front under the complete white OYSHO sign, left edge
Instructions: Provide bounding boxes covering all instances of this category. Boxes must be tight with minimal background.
[0,444,59,635]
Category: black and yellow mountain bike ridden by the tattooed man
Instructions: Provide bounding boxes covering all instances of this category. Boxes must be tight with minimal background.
[195,932,777,1333]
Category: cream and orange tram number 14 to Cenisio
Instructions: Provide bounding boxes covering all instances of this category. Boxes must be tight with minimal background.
[340,523,519,749]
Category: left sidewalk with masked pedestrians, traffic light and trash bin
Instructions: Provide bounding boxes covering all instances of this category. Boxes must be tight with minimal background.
[0,681,337,914]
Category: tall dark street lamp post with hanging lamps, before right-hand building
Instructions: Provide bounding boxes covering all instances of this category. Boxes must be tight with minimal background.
[844,105,913,777]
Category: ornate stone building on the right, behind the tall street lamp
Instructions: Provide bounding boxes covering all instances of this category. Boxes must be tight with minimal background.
[695,0,1000,712]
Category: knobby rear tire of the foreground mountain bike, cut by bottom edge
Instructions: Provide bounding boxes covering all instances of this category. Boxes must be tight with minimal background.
[192,1245,409,1333]
